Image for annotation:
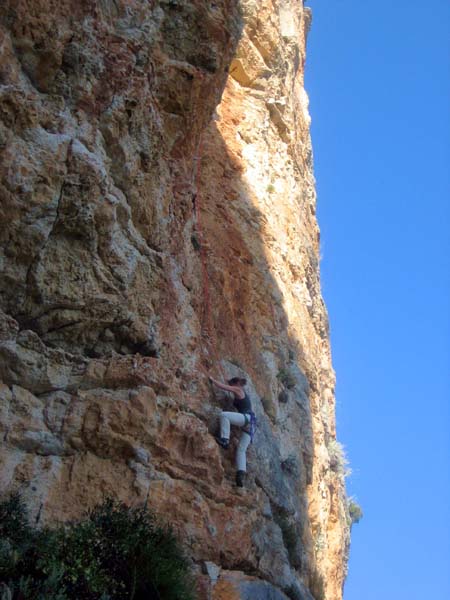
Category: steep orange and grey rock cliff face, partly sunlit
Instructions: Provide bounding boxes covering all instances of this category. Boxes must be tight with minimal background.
[0,0,349,600]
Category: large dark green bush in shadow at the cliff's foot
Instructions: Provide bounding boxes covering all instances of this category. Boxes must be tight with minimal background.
[0,495,194,600]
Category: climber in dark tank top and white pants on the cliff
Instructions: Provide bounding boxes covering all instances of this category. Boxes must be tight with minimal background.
[209,377,256,487]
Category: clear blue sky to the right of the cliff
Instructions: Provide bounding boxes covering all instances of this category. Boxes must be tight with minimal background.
[306,0,450,600]
